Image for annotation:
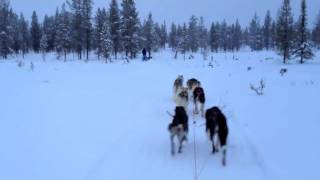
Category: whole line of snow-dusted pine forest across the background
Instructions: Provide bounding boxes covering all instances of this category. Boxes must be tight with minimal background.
[0,0,320,63]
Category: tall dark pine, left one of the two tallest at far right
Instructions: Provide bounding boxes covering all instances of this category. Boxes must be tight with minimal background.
[276,0,294,64]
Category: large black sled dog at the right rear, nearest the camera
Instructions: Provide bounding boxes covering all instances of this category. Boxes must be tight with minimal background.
[206,107,229,166]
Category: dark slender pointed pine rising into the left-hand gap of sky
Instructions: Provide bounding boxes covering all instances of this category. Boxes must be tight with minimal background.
[30,11,41,53]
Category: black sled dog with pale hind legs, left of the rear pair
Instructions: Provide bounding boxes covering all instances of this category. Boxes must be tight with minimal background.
[168,106,189,156]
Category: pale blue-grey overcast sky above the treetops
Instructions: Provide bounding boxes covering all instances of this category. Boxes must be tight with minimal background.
[11,0,320,25]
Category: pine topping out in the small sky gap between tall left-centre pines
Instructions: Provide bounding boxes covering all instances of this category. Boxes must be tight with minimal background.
[94,8,108,59]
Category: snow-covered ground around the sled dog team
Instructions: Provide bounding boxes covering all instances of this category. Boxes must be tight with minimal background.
[0,51,320,180]
